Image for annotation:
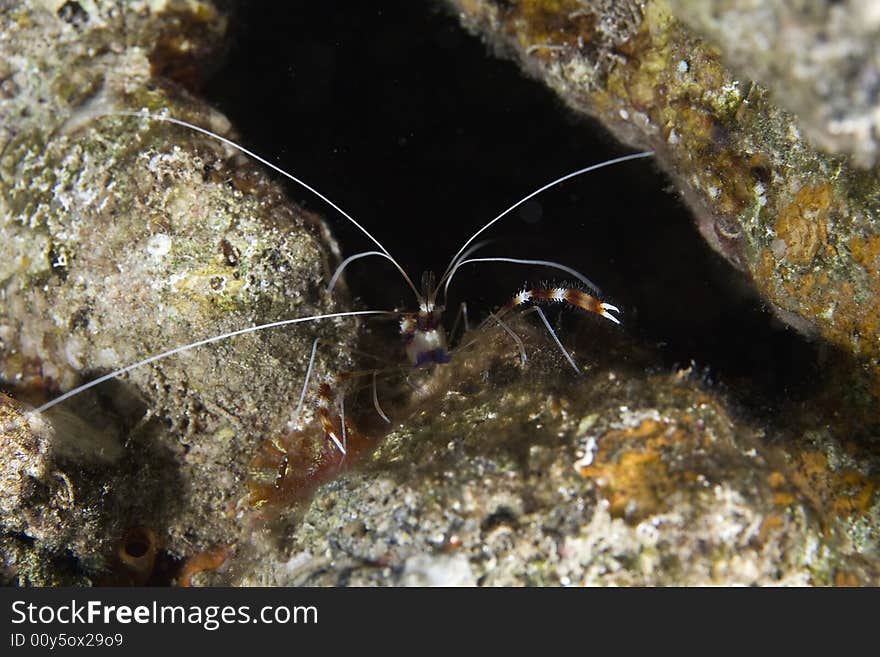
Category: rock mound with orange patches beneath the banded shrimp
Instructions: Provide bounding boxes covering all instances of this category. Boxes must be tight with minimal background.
[220,317,880,586]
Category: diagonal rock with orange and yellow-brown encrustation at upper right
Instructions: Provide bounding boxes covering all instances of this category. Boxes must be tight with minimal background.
[450,0,880,394]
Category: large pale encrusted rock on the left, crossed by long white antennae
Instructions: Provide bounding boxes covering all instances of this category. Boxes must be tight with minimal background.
[0,1,355,583]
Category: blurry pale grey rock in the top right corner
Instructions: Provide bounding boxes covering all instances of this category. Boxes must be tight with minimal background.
[669,0,880,167]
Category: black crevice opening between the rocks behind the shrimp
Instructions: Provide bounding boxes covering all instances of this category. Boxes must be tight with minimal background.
[203,0,822,412]
